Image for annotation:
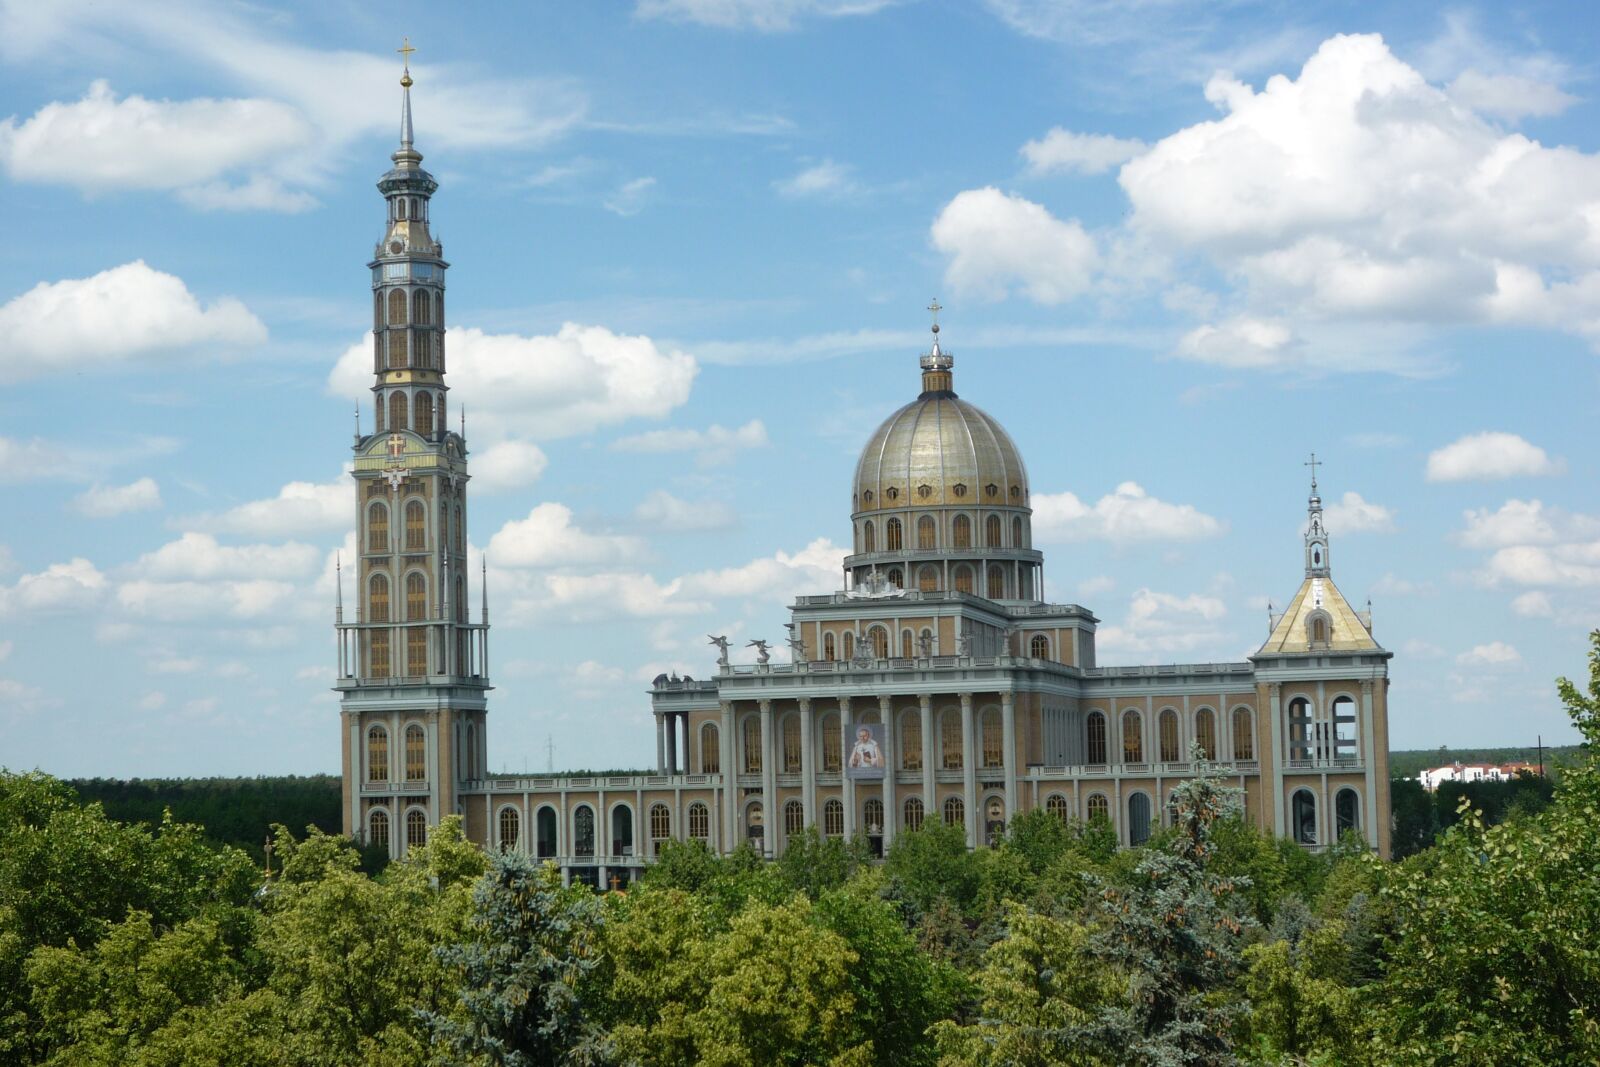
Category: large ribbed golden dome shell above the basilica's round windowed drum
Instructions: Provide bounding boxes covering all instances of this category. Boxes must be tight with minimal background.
[851,389,1029,512]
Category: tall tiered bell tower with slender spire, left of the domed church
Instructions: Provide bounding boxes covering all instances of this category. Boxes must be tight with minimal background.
[334,43,491,856]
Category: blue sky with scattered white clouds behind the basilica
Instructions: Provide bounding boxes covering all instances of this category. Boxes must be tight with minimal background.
[0,0,1600,776]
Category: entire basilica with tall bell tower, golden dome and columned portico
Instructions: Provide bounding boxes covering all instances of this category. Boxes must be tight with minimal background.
[336,62,1392,888]
